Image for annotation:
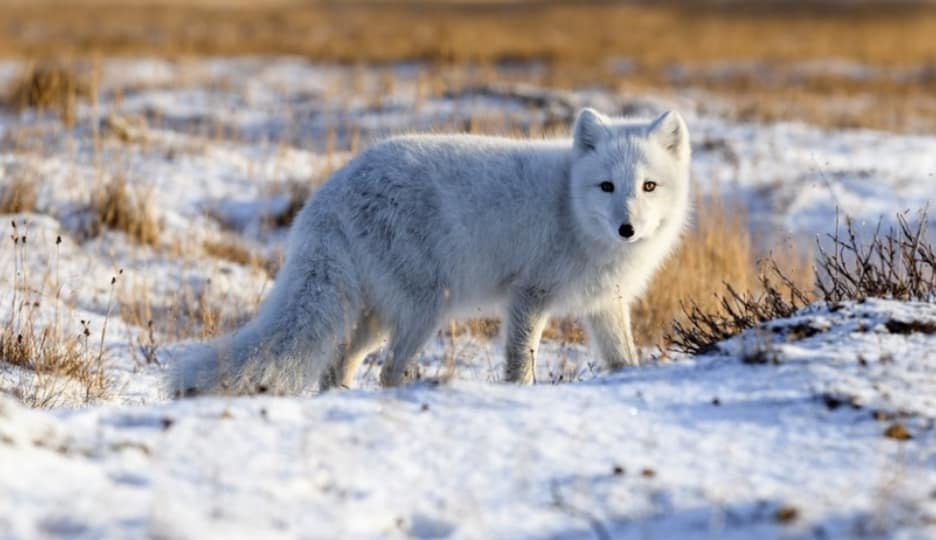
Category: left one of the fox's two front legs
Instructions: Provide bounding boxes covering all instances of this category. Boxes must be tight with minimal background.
[507,287,548,384]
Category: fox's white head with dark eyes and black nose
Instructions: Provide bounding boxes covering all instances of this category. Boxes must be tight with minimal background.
[571,109,690,251]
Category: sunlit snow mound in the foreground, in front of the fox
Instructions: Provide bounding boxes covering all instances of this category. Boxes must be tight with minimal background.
[0,300,936,538]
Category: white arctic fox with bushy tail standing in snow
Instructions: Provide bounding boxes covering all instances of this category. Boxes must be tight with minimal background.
[169,109,690,396]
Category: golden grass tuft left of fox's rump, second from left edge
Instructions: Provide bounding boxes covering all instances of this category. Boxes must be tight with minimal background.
[90,176,159,245]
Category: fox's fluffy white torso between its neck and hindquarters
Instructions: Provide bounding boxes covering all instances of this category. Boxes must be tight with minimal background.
[304,135,571,308]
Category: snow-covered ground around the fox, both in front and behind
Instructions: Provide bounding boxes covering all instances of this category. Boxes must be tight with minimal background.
[0,58,936,538]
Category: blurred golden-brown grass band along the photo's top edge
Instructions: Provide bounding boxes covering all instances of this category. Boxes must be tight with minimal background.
[0,0,936,69]
